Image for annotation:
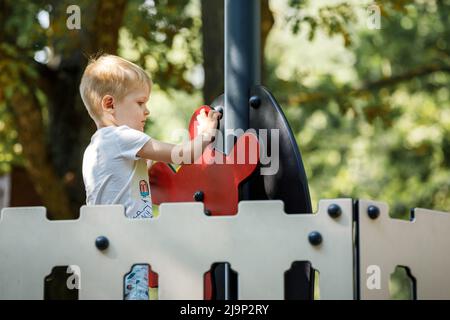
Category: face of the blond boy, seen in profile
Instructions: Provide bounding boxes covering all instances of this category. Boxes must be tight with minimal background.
[114,86,150,131]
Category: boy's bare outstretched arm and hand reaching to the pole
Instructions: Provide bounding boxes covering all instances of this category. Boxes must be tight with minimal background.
[137,110,221,164]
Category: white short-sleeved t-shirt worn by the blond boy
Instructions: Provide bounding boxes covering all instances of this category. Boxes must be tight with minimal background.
[83,126,153,218]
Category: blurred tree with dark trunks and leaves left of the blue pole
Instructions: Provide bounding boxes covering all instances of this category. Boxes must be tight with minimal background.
[0,0,273,219]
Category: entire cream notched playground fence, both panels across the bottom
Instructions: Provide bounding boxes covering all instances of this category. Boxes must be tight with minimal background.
[0,199,450,299]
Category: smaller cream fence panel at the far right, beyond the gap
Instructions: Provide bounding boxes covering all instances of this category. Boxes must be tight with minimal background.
[357,200,450,300]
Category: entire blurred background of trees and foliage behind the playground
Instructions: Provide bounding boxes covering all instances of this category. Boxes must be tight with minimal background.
[0,0,450,298]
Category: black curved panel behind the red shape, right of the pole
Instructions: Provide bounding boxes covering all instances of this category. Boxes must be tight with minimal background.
[211,86,312,213]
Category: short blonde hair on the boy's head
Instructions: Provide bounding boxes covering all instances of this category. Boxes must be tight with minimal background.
[80,54,152,121]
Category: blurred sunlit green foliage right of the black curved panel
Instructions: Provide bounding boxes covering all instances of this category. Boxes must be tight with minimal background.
[268,0,450,218]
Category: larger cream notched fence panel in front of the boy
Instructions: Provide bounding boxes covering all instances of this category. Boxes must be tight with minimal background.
[0,199,354,299]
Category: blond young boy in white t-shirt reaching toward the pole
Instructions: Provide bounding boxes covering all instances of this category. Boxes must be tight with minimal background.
[80,55,220,300]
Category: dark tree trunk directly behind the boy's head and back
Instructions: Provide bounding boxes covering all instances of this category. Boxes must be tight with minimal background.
[47,0,127,216]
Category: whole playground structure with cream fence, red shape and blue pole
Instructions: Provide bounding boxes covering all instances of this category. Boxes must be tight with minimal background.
[0,0,450,300]
